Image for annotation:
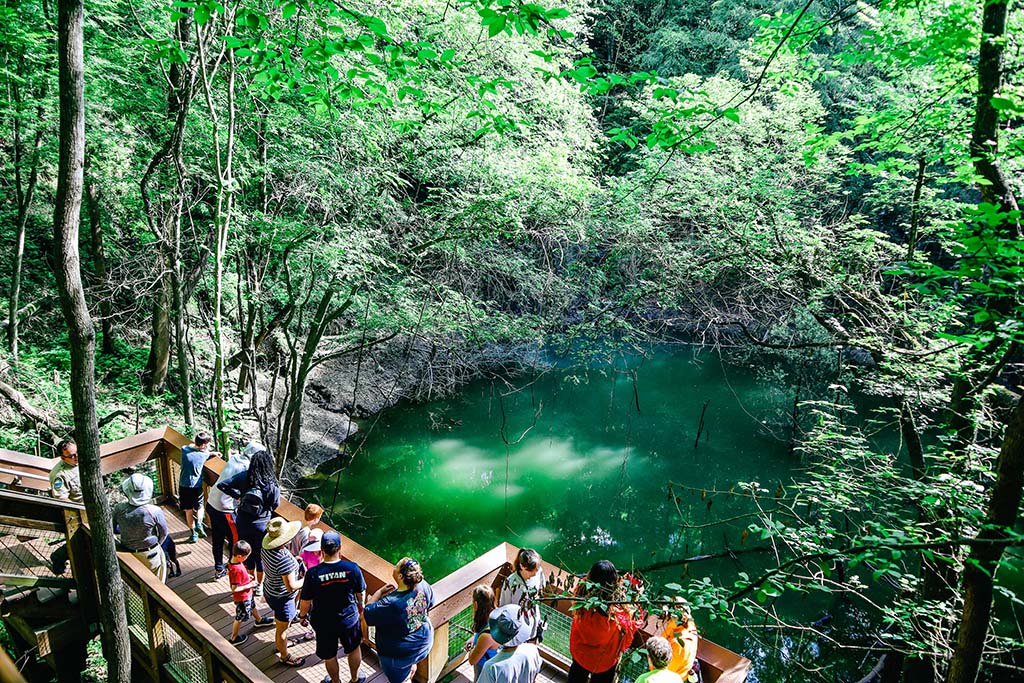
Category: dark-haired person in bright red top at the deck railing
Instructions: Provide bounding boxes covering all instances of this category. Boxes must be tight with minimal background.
[566,560,640,683]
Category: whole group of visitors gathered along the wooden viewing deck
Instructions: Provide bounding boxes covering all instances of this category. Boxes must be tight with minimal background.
[50,432,699,683]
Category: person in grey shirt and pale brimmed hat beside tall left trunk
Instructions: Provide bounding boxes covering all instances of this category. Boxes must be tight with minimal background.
[114,473,167,583]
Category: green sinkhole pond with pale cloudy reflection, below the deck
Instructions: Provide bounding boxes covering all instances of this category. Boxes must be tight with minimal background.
[296,346,880,680]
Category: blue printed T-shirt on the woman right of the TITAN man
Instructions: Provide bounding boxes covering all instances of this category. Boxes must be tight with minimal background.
[364,581,434,658]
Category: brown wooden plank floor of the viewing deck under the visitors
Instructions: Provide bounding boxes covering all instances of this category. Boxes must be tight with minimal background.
[163,505,565,683]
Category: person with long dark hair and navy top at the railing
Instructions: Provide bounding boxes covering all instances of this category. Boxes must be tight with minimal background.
[217,445,281,596]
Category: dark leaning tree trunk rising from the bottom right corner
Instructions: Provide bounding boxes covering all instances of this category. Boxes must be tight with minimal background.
[946,399,1024,683]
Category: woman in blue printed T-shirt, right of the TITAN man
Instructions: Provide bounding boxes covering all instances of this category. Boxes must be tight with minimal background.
[364,557,434,683]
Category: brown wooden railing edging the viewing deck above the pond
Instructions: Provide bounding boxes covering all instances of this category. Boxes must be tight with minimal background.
[0,427,751,683]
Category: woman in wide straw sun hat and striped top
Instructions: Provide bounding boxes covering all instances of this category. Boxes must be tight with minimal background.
[260,517,306,667]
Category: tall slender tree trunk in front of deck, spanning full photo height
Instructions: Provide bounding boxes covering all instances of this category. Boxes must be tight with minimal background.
[53,0,131,683]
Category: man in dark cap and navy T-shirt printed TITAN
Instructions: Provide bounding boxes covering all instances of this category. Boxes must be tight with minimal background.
[299,530,367,683]
